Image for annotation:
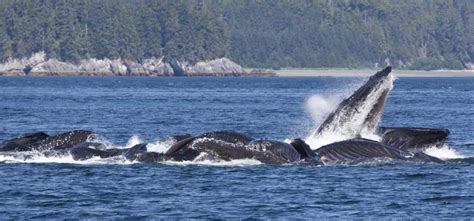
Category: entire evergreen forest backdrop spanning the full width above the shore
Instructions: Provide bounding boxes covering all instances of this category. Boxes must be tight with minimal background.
[0,0,474,69]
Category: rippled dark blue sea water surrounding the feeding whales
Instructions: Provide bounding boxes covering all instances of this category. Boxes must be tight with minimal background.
[0,77,474,219]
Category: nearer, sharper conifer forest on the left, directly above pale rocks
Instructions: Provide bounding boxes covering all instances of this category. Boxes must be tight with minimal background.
[0,0,228,62]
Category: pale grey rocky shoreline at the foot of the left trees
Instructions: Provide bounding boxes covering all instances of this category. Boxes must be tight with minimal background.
[0,52,275,76]
